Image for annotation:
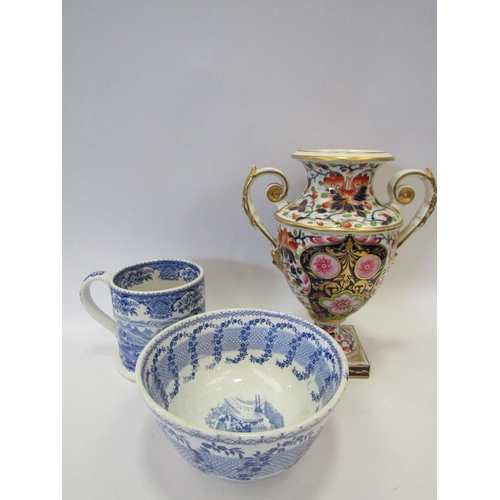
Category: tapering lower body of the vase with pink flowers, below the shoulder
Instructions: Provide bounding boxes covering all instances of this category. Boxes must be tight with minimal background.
[278,227,398,323]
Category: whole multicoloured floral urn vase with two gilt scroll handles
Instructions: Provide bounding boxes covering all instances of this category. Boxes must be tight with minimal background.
[243,150,437,378]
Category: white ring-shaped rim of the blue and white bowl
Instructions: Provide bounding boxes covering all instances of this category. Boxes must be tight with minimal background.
[135,308,349,441]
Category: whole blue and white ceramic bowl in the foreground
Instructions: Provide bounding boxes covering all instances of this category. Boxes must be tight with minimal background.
[136,309,349,481]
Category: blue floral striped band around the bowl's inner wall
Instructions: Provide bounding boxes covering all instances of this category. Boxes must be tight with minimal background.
[144,312,342,410]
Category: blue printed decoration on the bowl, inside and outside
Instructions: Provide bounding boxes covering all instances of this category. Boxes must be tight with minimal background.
[137,310,348,481]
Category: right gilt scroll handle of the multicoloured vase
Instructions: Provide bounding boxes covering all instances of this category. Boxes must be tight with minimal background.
[387,168,437,248]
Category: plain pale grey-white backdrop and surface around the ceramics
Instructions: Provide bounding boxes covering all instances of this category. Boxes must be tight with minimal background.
[63,0,439,500]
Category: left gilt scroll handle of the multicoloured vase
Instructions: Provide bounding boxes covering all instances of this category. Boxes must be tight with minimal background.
[243,165,288,267]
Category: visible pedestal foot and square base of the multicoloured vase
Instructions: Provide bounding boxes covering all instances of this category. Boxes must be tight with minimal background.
[315,321,370,378]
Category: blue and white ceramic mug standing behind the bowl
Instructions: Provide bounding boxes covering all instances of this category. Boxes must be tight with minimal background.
[80,259,205,380]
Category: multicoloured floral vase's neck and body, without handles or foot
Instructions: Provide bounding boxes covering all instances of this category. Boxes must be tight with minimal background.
[275,152,403,324]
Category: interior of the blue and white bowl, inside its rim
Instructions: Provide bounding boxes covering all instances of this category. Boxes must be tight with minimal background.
[139,310,345,432]
